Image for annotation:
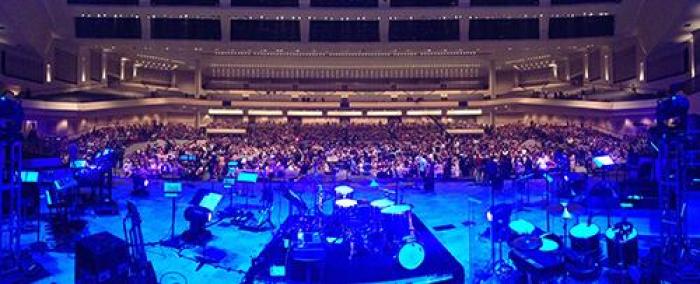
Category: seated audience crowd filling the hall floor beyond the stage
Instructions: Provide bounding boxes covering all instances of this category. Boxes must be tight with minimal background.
[42,119,647,180]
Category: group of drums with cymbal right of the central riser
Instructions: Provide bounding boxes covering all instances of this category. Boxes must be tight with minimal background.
[505,202,639,283]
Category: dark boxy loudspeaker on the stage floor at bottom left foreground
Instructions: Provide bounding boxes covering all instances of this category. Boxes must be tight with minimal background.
[75,232,129,284]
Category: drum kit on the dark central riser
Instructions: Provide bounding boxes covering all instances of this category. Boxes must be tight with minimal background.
[292,185,425,270]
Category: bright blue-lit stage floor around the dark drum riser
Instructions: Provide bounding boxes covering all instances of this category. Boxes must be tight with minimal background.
[23,176,700,283]
